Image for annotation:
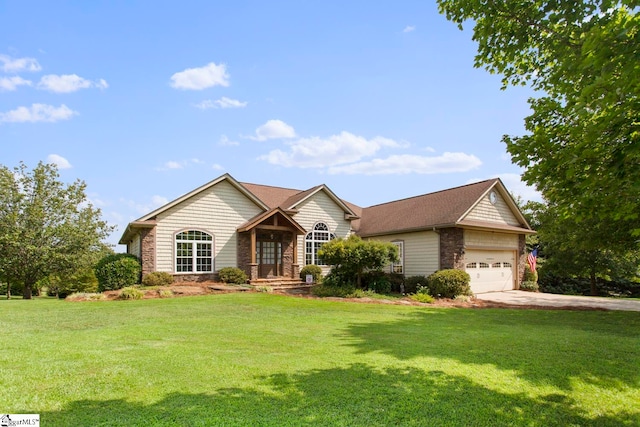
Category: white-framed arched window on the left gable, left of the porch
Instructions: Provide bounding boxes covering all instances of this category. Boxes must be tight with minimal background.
[175,230,213,273]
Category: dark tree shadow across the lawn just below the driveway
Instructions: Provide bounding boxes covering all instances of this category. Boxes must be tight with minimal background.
[342,309,640,390]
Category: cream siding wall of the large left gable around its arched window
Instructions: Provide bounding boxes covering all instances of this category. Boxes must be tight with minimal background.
[156,181,262,273]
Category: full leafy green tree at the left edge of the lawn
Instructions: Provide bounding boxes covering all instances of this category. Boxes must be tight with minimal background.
[0,162,113,299]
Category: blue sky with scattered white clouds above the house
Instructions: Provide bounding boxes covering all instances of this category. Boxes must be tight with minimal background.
[0,0,537,247]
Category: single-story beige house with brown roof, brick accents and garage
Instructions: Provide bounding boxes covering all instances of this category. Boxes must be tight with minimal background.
[119,174,533,293]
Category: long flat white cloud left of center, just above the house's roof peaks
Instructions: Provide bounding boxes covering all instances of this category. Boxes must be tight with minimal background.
[259,131,401,168]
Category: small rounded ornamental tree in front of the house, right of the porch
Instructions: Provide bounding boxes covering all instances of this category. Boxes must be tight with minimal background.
[318,234,398,288]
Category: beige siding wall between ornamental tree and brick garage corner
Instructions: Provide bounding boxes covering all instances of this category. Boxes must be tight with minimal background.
[367,231,440,277]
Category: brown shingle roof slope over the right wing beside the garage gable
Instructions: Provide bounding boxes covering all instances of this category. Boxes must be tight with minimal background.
[353,179,500,236]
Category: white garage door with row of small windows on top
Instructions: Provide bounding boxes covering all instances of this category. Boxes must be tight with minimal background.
[465,250,516,294]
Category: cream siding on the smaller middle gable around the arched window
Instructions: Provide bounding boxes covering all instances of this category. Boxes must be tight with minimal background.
[293,190,351,274]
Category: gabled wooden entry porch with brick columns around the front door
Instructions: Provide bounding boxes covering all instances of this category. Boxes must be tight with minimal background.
[237,208,305,282]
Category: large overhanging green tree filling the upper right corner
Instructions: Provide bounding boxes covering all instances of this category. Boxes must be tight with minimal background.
[438,0,640,245]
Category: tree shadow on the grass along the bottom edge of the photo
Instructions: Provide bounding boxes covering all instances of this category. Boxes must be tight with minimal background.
[41,364,640,426]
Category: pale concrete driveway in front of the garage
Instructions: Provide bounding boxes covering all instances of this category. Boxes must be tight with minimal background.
[476,291,640,311]
